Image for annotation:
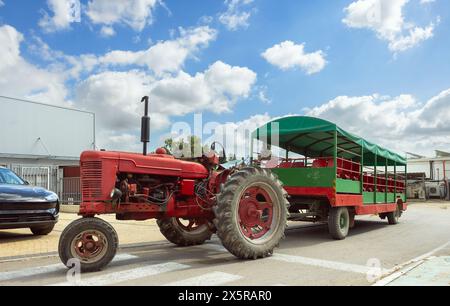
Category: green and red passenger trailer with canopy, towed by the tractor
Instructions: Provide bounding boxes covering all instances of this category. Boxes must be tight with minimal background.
[252,116,407,239]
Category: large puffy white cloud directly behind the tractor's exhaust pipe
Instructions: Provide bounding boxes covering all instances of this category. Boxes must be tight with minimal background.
[75,62,256,148]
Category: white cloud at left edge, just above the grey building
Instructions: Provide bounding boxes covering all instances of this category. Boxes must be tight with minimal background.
[0,25,69,106]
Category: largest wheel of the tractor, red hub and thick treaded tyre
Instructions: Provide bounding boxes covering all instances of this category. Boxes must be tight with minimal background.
[214,168,289,259]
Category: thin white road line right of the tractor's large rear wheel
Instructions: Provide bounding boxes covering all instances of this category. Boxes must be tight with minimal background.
[268,254,372,274]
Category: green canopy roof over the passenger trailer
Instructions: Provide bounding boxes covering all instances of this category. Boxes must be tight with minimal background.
[252,116,406,166]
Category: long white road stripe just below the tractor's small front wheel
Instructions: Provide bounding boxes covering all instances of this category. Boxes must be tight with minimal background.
[51,262,190,286]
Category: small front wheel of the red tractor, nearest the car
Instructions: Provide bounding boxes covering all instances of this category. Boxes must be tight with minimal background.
[58,218,119,272]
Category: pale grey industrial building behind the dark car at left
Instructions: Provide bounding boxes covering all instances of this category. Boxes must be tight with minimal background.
[0,96,96,203]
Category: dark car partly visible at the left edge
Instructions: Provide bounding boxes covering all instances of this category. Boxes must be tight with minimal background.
[0,167,59,235]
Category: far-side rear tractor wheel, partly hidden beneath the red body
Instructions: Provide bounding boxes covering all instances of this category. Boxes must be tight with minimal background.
[157,218,212,247]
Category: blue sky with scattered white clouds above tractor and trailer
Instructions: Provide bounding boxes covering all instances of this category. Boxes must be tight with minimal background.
[0,0,450,155]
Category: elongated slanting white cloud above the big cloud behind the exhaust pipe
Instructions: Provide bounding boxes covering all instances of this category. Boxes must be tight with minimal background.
[99,26,217,75]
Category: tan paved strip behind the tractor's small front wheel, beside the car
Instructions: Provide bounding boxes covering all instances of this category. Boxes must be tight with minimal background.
[0,213,166,259]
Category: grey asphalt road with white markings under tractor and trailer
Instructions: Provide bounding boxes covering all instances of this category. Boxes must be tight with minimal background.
[0,204,450,286]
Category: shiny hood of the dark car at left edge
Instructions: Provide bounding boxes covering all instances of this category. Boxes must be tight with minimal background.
[0,184,58,202]
